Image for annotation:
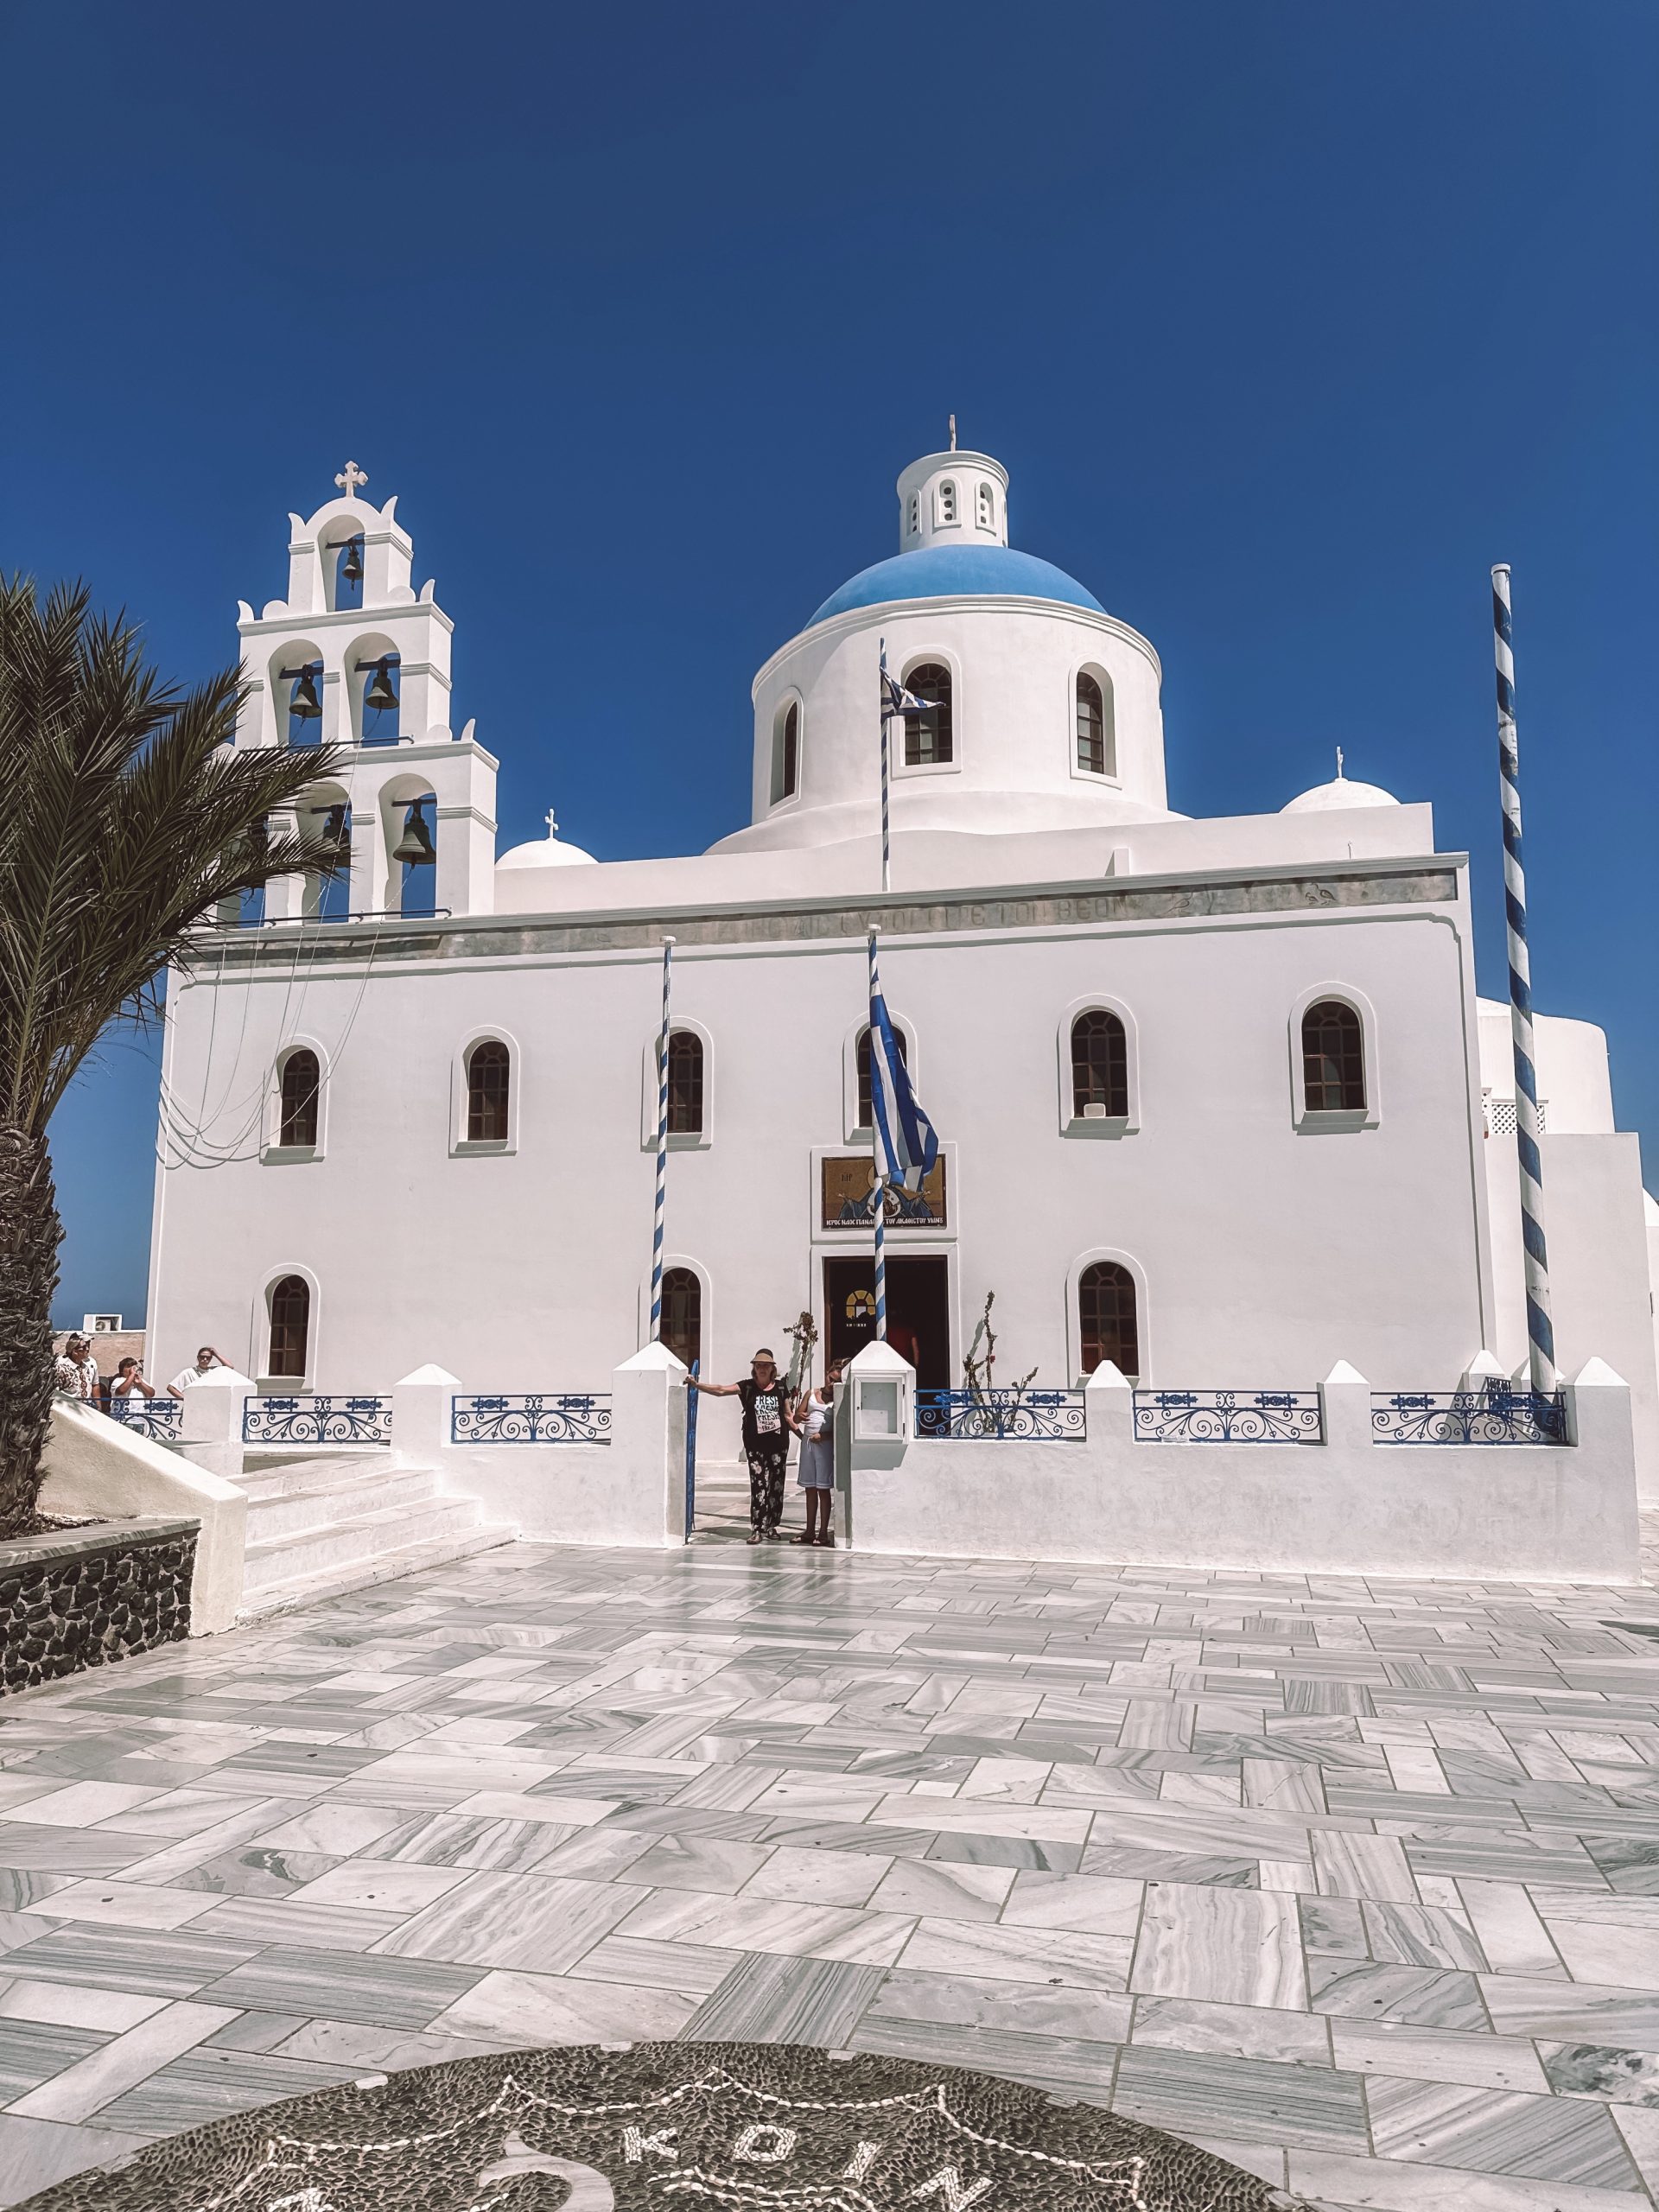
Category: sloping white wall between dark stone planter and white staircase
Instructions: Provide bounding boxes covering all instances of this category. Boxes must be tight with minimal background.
[40,1378,248,1637]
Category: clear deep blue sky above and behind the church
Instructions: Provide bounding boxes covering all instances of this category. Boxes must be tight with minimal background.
[0,0,1659,1316]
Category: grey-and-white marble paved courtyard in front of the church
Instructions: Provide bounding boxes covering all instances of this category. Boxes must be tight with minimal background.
[0,1544,1659,2212]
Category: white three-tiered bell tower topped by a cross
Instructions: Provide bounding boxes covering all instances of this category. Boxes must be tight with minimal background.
[237,460,498,920]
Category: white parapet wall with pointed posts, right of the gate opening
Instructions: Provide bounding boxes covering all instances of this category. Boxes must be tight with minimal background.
[836,1344,1642,1584]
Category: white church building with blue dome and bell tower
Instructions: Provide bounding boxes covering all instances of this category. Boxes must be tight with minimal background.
[150,437,1659,1493]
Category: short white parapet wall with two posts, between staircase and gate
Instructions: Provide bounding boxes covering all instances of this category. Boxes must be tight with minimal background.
[391,1344,686,1548]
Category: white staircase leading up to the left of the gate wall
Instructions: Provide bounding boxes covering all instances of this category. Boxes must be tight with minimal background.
[238,1446,513,1619]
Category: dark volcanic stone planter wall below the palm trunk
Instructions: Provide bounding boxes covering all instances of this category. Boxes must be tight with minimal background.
[0,1520,199,1690]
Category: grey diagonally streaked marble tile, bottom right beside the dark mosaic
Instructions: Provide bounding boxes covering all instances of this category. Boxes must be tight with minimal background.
[1365,2075,1639,2190]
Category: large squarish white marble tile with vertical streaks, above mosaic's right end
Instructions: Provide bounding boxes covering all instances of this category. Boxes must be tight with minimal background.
[1130,1883,1307,2011]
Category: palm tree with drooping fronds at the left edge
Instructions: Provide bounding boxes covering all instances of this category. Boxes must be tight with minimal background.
[0,575,343,1537]
